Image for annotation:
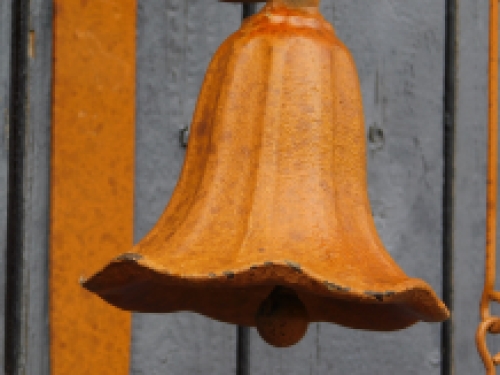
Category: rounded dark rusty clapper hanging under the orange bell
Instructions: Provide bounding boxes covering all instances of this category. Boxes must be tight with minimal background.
[255,286,309,348]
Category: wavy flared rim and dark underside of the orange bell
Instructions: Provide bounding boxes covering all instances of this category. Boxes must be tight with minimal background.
[83,253,450,331]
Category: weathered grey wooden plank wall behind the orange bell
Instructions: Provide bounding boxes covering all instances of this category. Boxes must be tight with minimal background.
[0,0,500,375]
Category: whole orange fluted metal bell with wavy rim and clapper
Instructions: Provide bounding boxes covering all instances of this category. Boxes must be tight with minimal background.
[84,0,449,346]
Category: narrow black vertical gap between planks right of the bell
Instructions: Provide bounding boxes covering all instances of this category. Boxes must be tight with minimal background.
[441,0,457,375]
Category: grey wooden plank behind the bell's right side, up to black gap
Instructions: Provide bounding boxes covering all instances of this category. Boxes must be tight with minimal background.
[250,0,445,375]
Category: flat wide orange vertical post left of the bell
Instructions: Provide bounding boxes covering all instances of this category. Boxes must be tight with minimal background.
[50,0,136,375]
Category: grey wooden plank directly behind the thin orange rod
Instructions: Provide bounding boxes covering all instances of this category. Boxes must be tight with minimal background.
[454,0,500,374]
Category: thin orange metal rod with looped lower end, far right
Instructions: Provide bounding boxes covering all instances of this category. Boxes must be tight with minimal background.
[476,0,500,375]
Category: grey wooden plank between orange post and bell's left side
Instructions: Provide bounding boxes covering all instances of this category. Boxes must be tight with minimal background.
[132,0,241,375]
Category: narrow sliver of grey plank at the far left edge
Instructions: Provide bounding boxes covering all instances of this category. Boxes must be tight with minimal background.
[0,1,11,369]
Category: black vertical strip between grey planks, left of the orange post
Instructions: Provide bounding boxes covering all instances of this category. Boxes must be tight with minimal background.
[5,0,29,375]
